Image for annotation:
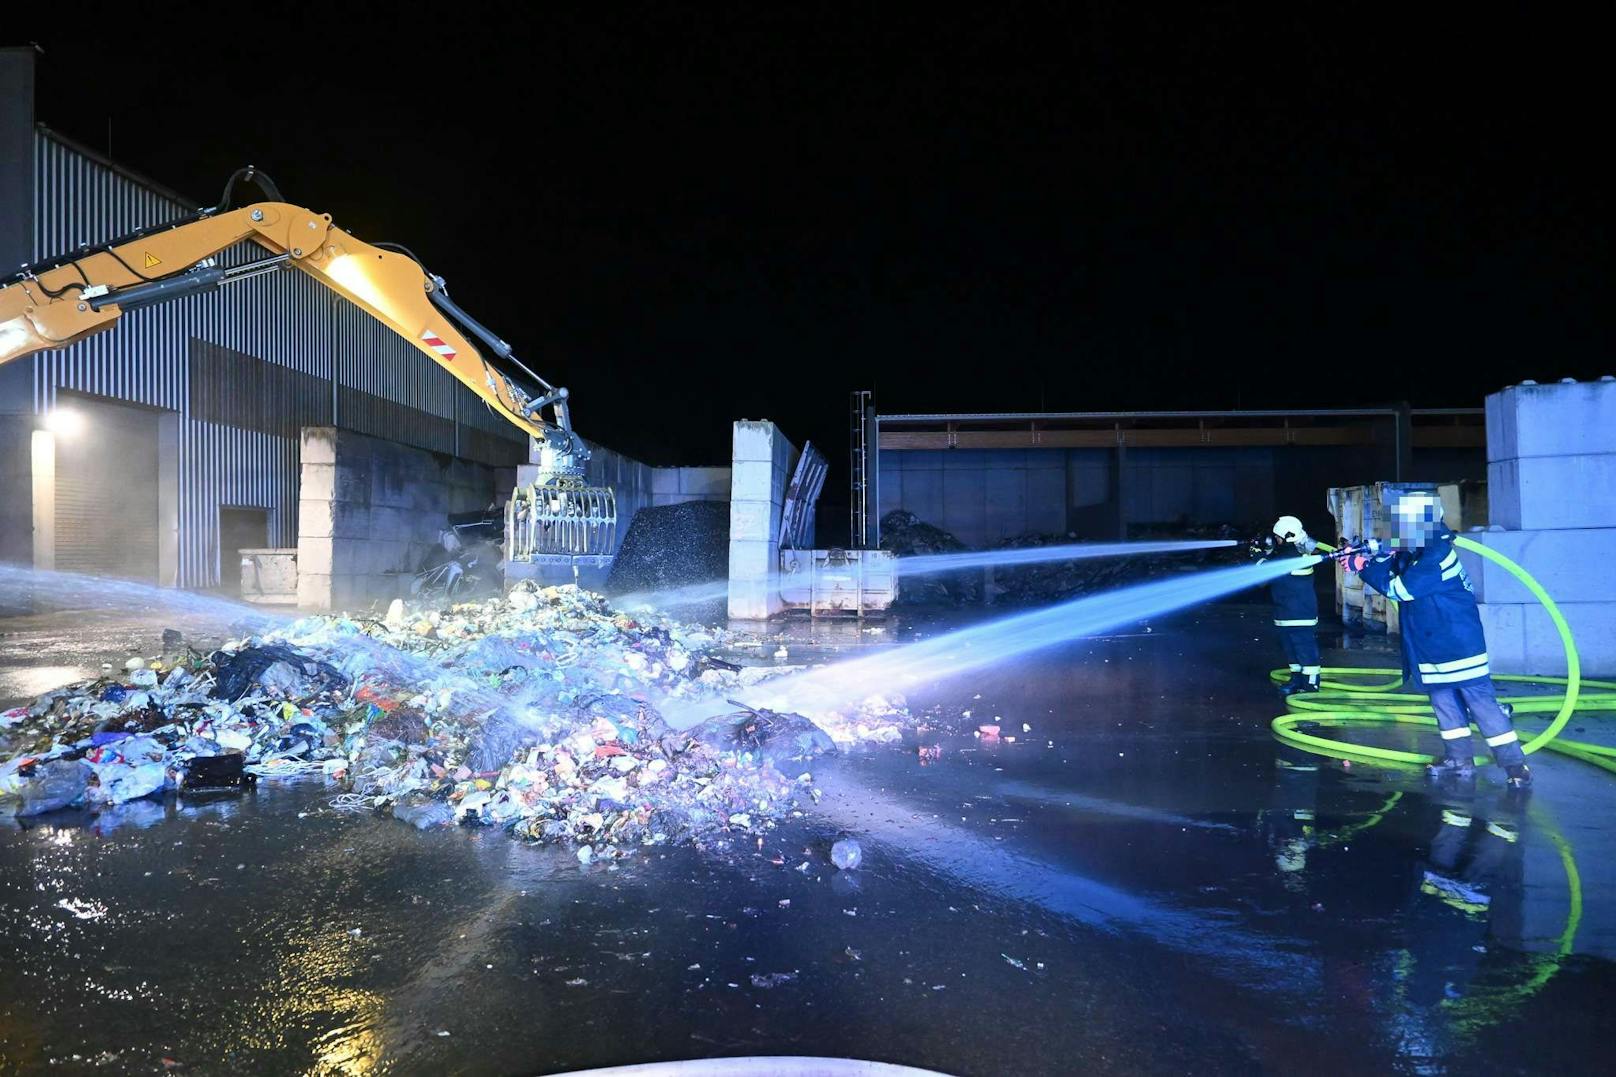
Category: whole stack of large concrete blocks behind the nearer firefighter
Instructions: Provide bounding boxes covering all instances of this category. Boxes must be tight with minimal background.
[1464,377,1616,676]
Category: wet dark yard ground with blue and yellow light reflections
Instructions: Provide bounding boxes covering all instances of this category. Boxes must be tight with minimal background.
[0,606,1616,1074]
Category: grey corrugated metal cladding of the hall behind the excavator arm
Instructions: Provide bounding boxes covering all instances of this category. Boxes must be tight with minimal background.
[31,129,527,587]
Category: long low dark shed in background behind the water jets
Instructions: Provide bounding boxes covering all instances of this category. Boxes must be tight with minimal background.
[855,406,1487,547]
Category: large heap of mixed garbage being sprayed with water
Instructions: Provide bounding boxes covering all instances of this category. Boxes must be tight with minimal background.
[0,584,908,860]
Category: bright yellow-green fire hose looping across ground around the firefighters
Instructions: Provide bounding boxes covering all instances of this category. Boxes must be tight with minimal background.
[1270,539,1616,773]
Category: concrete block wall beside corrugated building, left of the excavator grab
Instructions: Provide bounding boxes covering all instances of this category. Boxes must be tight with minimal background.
[297,427,514,610]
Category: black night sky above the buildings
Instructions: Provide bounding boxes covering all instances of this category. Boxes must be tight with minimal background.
[5,3,1616,465]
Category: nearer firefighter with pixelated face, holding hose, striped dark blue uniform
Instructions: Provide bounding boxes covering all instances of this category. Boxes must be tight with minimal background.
[1346,493,1532,789]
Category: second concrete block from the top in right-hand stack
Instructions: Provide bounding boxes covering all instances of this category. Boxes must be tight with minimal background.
[1487,453,1616,530]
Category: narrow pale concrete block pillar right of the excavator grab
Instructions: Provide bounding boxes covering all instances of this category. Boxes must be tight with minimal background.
[729,419,798,619]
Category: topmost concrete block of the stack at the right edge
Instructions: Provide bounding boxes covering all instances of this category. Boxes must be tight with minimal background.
[1487,380,1616,461]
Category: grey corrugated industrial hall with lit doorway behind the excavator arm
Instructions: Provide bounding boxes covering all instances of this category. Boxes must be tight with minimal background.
[0,49,527,589]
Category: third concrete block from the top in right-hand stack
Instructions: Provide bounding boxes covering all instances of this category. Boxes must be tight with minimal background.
[1459,527,1616,603]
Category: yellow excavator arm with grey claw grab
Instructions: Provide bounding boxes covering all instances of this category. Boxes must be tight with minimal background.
[0,167,617,561]
